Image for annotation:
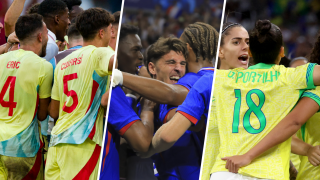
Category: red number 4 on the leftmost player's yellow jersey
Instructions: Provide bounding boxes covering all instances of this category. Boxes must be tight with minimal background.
[0,76,17,116]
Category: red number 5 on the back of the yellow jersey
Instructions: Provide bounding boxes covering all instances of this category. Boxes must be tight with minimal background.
[62,73,78,113]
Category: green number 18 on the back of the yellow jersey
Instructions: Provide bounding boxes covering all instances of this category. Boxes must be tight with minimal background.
[232,89,267,134]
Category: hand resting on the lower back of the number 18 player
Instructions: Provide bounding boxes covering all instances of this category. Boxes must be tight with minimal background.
[221,155,252,173]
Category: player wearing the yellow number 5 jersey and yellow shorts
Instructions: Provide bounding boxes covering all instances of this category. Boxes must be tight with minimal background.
[45,8,114,179]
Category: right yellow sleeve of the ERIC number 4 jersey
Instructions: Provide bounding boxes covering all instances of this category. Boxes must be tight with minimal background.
[39,61,53,99]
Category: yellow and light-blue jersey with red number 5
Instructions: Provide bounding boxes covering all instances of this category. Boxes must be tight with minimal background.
[50,45,114,146]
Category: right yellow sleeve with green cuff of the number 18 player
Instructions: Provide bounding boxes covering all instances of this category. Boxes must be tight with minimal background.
[286,63,316,89]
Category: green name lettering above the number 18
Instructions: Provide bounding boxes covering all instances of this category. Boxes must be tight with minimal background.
[228,71,280,83]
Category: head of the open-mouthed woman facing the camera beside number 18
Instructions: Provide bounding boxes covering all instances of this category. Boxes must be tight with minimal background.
[218,22,249,69]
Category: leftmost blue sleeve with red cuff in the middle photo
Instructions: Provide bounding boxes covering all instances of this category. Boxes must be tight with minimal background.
[108,86,140,136]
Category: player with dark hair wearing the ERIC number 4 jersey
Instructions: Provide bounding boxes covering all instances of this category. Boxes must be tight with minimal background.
[0,14,53,180]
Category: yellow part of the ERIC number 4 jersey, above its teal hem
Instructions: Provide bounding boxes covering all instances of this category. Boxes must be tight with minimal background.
[0,49,53,142]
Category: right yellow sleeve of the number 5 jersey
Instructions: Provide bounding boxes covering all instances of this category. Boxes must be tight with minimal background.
[93,47,114,77]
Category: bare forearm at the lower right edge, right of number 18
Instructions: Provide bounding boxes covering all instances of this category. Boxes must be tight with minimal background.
[291,135,320,166]
